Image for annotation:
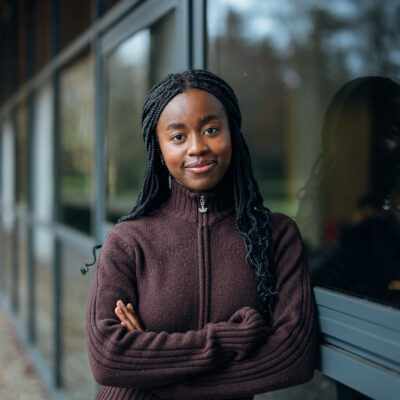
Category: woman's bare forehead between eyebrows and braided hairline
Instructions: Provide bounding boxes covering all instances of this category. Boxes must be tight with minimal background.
[158,89,226,124]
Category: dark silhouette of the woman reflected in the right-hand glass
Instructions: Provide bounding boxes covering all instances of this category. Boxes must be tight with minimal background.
[300,77,400,305]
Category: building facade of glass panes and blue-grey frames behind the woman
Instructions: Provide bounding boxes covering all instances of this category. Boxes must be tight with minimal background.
[0,0,400,399]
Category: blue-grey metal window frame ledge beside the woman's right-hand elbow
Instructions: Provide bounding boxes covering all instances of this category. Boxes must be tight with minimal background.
[314,287,400,400]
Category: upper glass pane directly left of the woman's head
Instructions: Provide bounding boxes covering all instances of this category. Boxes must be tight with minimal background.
[106,13,176,222]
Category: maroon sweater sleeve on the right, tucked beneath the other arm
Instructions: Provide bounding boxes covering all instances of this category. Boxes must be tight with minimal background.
[151,220,317,400]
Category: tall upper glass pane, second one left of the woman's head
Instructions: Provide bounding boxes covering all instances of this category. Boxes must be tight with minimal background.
[59,56,94,233]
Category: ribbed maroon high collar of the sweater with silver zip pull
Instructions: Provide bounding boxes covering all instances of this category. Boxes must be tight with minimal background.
[165,172,234,224]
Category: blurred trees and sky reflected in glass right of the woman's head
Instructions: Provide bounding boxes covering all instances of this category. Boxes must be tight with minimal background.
[209,0,400,211]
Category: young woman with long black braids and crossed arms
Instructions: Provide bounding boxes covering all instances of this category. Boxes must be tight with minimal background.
[87,70,317,399]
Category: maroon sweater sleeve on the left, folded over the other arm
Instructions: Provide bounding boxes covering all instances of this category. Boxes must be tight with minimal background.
[86,232,267,389]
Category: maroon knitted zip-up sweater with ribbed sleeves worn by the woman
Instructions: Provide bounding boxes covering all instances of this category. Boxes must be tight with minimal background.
[86,179,317,400]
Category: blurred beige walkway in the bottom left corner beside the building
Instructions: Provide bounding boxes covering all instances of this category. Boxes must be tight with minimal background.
[0,306,48,400]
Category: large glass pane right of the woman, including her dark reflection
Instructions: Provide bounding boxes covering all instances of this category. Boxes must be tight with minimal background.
[207,0,400,304]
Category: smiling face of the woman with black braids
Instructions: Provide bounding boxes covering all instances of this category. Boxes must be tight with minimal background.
[157,89,232,192]
